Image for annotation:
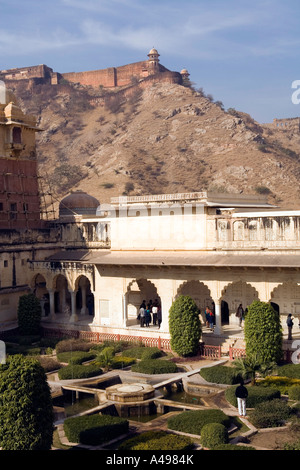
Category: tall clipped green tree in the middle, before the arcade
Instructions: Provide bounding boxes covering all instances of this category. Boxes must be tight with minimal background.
[169,295,202,356]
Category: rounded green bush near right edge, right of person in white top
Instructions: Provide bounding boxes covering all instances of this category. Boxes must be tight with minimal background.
[250,399,291,428]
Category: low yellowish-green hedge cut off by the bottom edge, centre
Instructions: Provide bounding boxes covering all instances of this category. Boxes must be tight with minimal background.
[118,431,193,451]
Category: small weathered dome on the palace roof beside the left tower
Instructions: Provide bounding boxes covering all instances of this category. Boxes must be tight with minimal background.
[59,189,100,217]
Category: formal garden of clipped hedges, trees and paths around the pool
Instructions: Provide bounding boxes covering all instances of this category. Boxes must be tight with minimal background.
[0,295,300,450]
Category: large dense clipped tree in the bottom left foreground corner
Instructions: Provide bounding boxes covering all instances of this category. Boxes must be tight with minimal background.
[0,355,54,450]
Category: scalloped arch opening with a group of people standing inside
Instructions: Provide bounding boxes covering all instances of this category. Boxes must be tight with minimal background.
[125,278,161,326]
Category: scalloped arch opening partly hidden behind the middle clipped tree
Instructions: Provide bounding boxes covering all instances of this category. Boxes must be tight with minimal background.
[175,280,215,324]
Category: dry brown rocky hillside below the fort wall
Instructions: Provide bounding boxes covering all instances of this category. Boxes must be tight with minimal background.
[9,82,300,209]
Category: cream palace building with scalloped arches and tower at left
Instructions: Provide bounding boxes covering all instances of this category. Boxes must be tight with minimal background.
[0,83,300,352]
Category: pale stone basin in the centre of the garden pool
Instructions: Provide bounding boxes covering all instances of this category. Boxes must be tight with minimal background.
[106,384,155,403]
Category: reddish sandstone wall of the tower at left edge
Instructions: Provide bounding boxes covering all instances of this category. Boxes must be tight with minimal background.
[0,158,41,229]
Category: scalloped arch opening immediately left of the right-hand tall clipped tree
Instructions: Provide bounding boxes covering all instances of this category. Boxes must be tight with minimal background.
[221,280,259,323]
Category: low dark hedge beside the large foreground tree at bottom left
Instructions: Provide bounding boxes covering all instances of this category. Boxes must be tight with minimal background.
[64,414,129,445]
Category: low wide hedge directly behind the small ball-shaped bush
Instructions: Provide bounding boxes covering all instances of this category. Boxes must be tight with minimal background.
[168,409,230,435]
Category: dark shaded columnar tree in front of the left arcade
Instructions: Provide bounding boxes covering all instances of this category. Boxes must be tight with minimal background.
[18,294,42,335]
